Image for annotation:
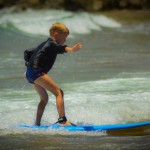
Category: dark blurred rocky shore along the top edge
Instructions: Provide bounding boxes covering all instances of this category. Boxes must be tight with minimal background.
[0,0,150,12]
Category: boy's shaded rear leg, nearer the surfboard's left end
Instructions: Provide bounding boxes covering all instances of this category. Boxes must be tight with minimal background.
[32,84,48,126]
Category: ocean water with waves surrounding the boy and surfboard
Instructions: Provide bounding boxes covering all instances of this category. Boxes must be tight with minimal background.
[0,9,150,150]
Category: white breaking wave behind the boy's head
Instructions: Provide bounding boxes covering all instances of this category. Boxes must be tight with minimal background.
[0,9,121,36]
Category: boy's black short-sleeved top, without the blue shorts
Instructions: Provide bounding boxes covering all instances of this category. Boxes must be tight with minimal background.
[28,38,66,73]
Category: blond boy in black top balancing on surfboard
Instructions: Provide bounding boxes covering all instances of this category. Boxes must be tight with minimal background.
[26,22,82,126]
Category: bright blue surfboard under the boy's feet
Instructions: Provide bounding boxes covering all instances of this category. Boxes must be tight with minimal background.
[19,122,150,132]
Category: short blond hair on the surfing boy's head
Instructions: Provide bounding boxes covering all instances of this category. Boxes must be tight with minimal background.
[49,22,69,36]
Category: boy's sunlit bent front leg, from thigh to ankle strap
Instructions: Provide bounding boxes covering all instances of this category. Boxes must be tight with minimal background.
[35,74,65,117]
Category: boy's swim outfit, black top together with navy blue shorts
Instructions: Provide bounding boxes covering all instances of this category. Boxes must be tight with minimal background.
[26,38,66,83]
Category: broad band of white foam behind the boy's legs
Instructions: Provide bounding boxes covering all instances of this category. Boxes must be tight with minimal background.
[0,78,150,135]
